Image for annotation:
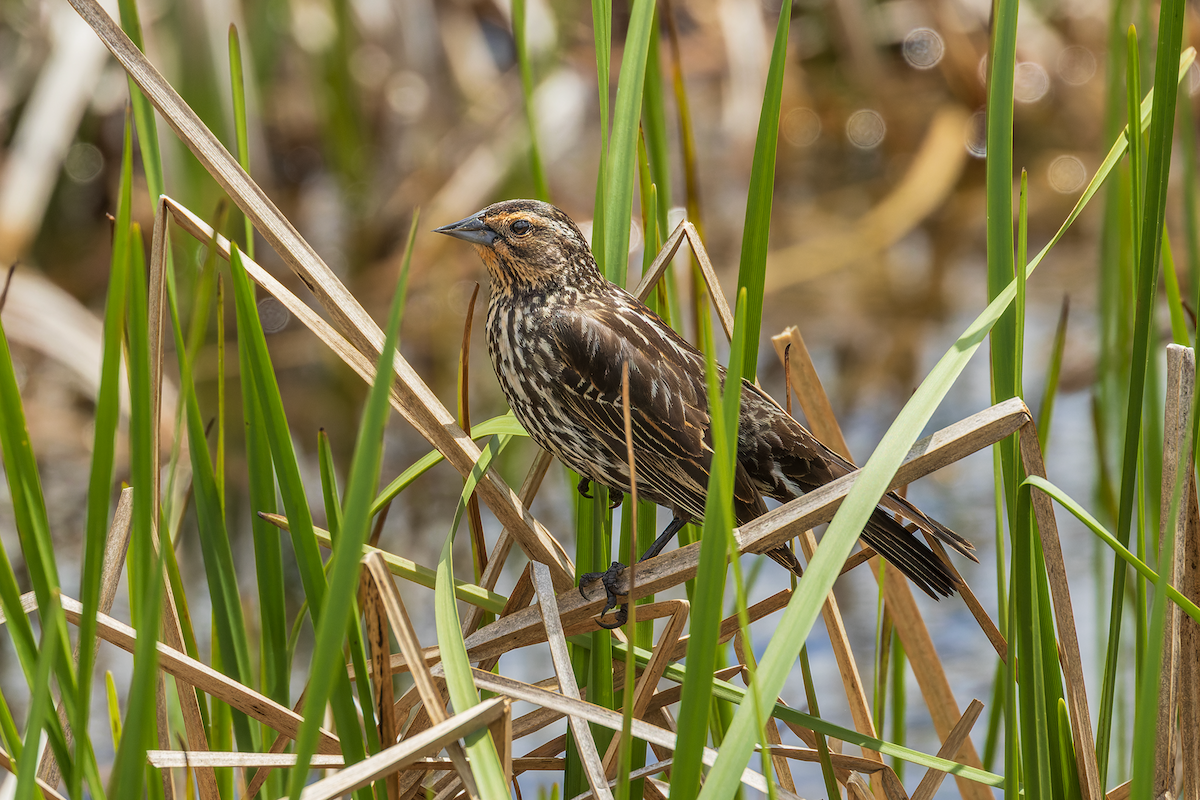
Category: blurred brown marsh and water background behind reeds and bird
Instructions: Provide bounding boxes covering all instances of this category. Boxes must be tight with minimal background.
[0,0,1180,780]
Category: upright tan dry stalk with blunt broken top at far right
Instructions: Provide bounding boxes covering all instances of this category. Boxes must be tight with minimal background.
[1154,344,1200,798]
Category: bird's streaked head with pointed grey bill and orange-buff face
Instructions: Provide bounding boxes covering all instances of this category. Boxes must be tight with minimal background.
[434,200,602,293]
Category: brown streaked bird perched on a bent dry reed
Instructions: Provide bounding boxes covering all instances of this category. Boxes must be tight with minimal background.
[434,199,977,627]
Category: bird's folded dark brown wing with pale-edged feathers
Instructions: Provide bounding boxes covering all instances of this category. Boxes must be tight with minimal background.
[553,297,712,517]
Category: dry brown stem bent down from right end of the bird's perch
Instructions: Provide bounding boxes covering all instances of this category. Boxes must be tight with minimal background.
[1019,419,1104,800]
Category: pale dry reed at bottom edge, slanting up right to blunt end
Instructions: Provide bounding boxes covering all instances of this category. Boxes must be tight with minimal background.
[300,697,511,800]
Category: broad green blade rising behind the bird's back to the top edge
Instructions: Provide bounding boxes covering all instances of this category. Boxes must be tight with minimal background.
[738,2,792,381]
